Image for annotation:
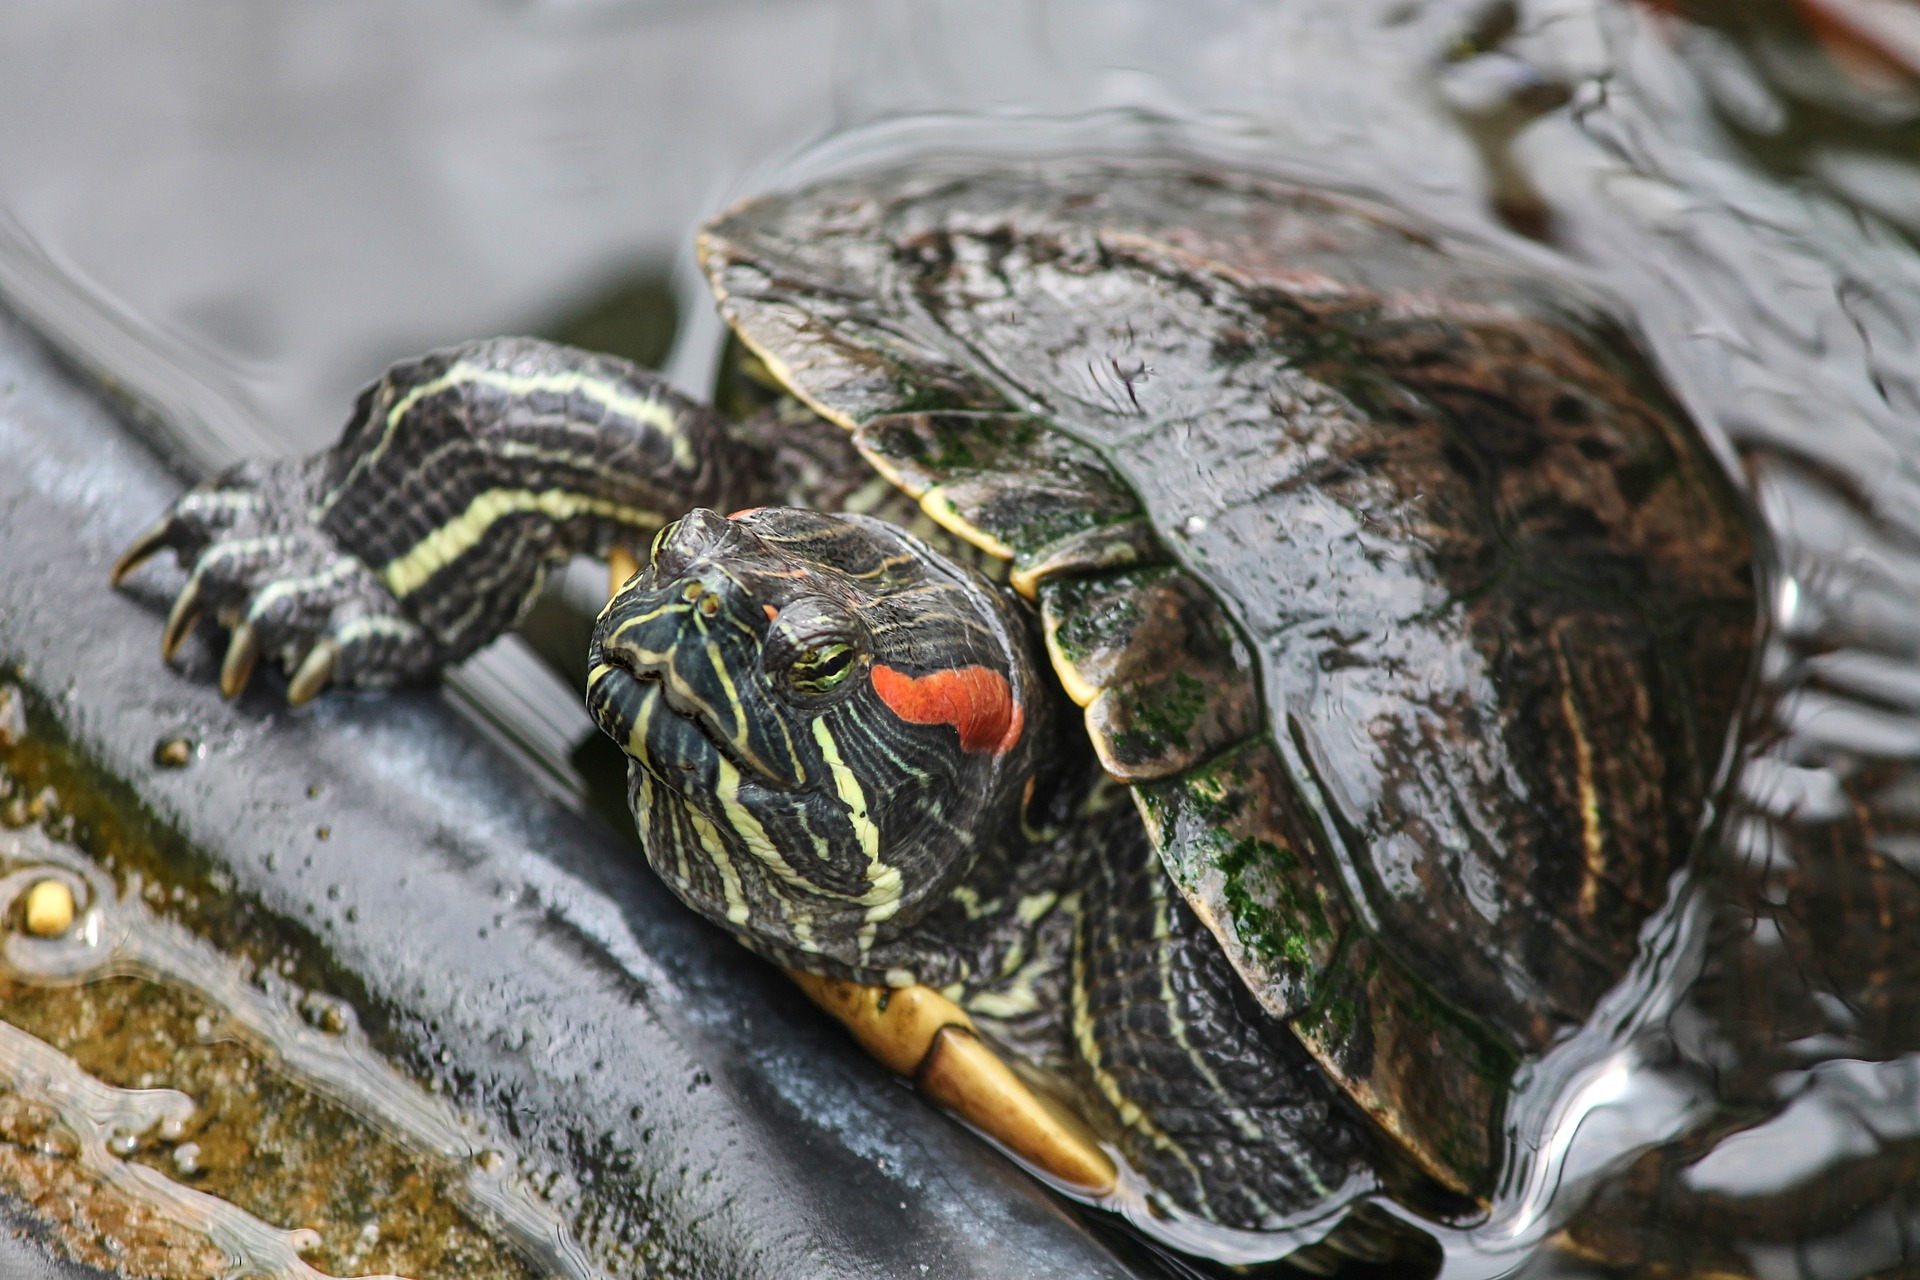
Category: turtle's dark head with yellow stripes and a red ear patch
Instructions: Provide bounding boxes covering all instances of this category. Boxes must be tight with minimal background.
[588,507,1043,971]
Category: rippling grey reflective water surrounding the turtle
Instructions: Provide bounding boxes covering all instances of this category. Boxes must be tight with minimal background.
[0,0,1920,1276]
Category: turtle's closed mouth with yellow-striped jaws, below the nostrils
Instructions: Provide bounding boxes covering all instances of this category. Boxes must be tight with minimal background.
[588,649,791,794]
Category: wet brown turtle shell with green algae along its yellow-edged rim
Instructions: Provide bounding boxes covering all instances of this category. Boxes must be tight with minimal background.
[701,163,1755,1196]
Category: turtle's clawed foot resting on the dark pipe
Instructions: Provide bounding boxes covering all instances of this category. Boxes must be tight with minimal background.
[113,461,442,706]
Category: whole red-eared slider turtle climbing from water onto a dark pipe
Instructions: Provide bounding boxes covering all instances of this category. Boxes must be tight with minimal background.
[105,163,1753,1245]
